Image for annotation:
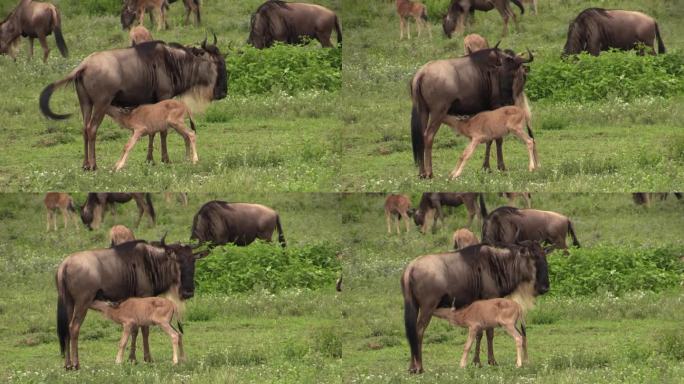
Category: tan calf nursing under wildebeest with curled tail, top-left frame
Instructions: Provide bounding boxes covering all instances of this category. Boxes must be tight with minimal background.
[107,100,198,171]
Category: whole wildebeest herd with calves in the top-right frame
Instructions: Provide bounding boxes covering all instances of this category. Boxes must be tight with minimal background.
[396,0,665,179]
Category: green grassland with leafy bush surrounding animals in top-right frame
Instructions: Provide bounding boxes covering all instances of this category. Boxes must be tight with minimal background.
[337,0,684,192]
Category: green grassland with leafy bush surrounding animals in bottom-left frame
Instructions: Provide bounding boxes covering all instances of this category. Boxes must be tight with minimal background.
[0,193,343,383]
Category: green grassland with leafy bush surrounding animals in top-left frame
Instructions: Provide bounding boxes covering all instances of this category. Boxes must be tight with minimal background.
[0,0,342,192]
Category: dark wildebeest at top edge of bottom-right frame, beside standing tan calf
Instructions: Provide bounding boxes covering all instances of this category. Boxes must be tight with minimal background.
[413,192,482,233]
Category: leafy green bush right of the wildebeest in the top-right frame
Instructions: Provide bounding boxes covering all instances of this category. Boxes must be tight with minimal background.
[525,51,684,102]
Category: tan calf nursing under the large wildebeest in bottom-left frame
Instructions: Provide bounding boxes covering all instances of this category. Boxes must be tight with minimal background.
[90,297,185,365]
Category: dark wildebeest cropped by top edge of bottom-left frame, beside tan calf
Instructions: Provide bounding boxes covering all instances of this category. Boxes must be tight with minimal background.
[81,192,156,230]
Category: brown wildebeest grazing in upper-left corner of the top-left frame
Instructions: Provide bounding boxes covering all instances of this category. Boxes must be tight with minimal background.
[0,0,69,63]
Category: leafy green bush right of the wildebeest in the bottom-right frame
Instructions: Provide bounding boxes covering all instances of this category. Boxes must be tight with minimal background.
[548,247,684,296]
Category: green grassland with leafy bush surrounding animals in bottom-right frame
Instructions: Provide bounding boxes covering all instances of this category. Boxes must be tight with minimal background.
[342,194,684,383]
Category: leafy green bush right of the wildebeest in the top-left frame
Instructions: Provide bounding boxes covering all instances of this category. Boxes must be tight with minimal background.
[227,41,342,95]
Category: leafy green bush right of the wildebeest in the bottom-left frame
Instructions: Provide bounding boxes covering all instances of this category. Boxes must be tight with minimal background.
[195,242,341,294]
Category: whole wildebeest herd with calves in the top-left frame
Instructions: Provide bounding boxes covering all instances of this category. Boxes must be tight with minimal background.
[0,0,342,171]
